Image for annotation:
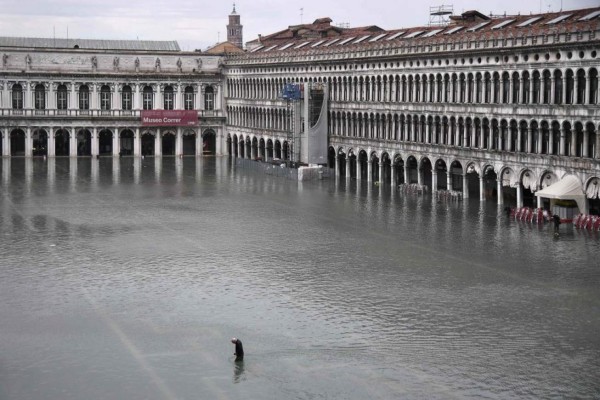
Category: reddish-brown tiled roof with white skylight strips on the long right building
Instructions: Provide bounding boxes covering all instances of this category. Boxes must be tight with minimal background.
[248,7,600,56]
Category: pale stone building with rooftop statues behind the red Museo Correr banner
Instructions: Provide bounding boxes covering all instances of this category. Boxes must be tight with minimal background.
[0,38,224,157]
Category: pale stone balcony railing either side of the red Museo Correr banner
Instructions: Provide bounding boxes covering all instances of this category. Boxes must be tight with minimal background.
[0,108,225,119]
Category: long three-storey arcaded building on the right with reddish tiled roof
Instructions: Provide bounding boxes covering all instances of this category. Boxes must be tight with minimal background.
[225,9,600,212]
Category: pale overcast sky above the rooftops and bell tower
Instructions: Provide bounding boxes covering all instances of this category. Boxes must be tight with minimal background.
[0,0,600,50]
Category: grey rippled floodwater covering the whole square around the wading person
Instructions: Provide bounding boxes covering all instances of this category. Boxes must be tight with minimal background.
[0,158,600,400]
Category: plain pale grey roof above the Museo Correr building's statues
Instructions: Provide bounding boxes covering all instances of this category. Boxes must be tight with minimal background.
[0,37,181,51]
